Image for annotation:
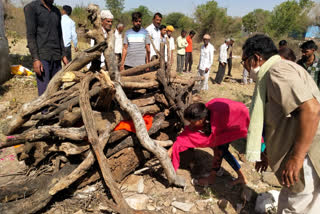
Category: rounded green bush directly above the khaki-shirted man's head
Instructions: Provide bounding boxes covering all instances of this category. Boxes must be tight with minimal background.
[242,9,271,33]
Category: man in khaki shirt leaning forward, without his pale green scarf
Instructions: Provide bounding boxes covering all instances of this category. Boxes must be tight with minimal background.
[242,35,320,214]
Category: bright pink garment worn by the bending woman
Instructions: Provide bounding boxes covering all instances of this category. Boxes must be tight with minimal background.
[172,98,250,170]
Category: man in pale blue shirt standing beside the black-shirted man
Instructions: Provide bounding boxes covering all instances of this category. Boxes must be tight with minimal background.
[61,5,78,62]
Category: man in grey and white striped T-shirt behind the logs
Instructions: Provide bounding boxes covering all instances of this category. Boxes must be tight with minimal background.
[120,12,150,70]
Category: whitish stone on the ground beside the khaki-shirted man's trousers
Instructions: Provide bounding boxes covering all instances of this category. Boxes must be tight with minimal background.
[254,190,280,213]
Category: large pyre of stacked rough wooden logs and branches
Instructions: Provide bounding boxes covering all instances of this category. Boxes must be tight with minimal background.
[0,5,202,213]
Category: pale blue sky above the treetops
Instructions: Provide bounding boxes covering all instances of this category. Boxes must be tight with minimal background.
[12,0,320,16]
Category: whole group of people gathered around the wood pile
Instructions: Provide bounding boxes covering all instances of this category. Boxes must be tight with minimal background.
[24,0,320,214]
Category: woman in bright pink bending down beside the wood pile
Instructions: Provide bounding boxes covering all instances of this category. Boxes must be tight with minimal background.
[168,98,250,185]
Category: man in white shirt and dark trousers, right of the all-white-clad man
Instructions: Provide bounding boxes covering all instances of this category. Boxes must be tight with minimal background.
[214,39,230,84]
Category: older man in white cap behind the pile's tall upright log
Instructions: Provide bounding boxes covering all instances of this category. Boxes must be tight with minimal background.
[88,10,113,70]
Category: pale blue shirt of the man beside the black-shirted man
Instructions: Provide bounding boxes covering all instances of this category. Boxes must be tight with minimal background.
[61,14,78,48]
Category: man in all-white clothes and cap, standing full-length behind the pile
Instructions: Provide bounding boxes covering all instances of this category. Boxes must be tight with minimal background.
[198,34,214,90]
